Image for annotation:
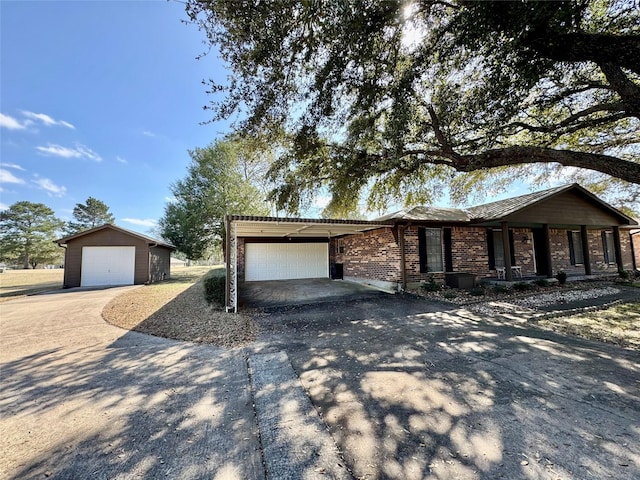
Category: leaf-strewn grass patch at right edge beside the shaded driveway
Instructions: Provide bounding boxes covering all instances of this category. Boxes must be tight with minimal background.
[537,303,640,350]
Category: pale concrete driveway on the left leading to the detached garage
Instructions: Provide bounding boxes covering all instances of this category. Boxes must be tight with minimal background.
[0,287,264,479]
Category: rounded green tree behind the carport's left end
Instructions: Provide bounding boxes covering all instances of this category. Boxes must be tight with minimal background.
[159,140,269,260]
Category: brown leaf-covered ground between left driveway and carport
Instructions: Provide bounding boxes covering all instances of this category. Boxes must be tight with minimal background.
[102,267,257,347]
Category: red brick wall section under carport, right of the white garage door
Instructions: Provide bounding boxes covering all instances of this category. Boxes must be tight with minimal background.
[335,228,400,283]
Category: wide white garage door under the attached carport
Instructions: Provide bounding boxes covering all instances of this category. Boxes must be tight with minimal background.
[244,243,329,281]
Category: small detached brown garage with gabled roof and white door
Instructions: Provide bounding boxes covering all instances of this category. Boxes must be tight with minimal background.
[56,224,175,288]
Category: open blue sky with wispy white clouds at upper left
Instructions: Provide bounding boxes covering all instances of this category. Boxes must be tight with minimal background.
[0,0,227,232]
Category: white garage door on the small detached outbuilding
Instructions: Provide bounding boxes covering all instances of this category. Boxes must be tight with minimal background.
[80,247,136,287]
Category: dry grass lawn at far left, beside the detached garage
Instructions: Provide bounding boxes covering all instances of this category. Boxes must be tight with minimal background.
[0,268,64,302]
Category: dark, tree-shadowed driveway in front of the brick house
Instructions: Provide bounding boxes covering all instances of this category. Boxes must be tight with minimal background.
[254,296,640,480]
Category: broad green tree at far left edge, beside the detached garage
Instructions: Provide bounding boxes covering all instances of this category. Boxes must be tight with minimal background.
[0,201,64,269]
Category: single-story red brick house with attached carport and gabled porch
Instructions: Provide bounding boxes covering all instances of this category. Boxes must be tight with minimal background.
[226,184,637,309]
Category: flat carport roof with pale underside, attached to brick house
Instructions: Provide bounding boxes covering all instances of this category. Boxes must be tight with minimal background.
[227,215,395,238]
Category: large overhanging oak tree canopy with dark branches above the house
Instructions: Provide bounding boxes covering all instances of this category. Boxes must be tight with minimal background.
[186,0,640,211]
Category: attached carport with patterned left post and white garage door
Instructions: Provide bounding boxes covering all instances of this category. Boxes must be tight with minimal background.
[225,215,394,311]
